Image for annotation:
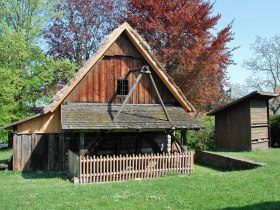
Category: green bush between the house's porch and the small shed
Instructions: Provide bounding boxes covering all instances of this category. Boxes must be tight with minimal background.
[187,116,215,150]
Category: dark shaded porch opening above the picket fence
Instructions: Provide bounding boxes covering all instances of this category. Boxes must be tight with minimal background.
[66,131,186,156]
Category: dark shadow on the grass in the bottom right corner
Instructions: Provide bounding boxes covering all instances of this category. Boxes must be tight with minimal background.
[222,201,280,210]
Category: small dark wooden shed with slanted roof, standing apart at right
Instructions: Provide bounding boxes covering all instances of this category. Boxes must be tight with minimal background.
[208,91,278,150]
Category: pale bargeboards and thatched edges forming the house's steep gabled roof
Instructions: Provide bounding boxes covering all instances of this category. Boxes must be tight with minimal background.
[43,22,196,114]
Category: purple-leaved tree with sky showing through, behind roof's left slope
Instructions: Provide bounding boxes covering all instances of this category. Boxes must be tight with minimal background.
[44,0,125,64]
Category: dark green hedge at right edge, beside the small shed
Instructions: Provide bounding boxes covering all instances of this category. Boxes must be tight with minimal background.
[269,115,280,147]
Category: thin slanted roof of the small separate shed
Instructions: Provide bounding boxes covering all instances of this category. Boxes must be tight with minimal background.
[207,91,279,116]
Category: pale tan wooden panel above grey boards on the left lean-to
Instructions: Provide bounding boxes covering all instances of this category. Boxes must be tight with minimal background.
[17,110,62,134]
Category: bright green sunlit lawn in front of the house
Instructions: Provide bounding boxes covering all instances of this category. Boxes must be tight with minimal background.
[0,149,280,209]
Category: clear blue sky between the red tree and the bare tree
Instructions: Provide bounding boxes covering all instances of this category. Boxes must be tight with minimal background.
[210,0,280,84]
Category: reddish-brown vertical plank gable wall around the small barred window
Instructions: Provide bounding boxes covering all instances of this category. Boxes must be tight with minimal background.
[63,34,177,104]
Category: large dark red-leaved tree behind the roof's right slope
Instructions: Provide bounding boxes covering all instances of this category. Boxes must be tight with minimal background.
[127,0,234,111]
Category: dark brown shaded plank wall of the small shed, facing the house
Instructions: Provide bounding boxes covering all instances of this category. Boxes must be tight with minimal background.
[215,100,251,150]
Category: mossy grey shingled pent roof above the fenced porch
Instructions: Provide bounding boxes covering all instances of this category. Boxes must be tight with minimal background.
[61,103,202,130]
